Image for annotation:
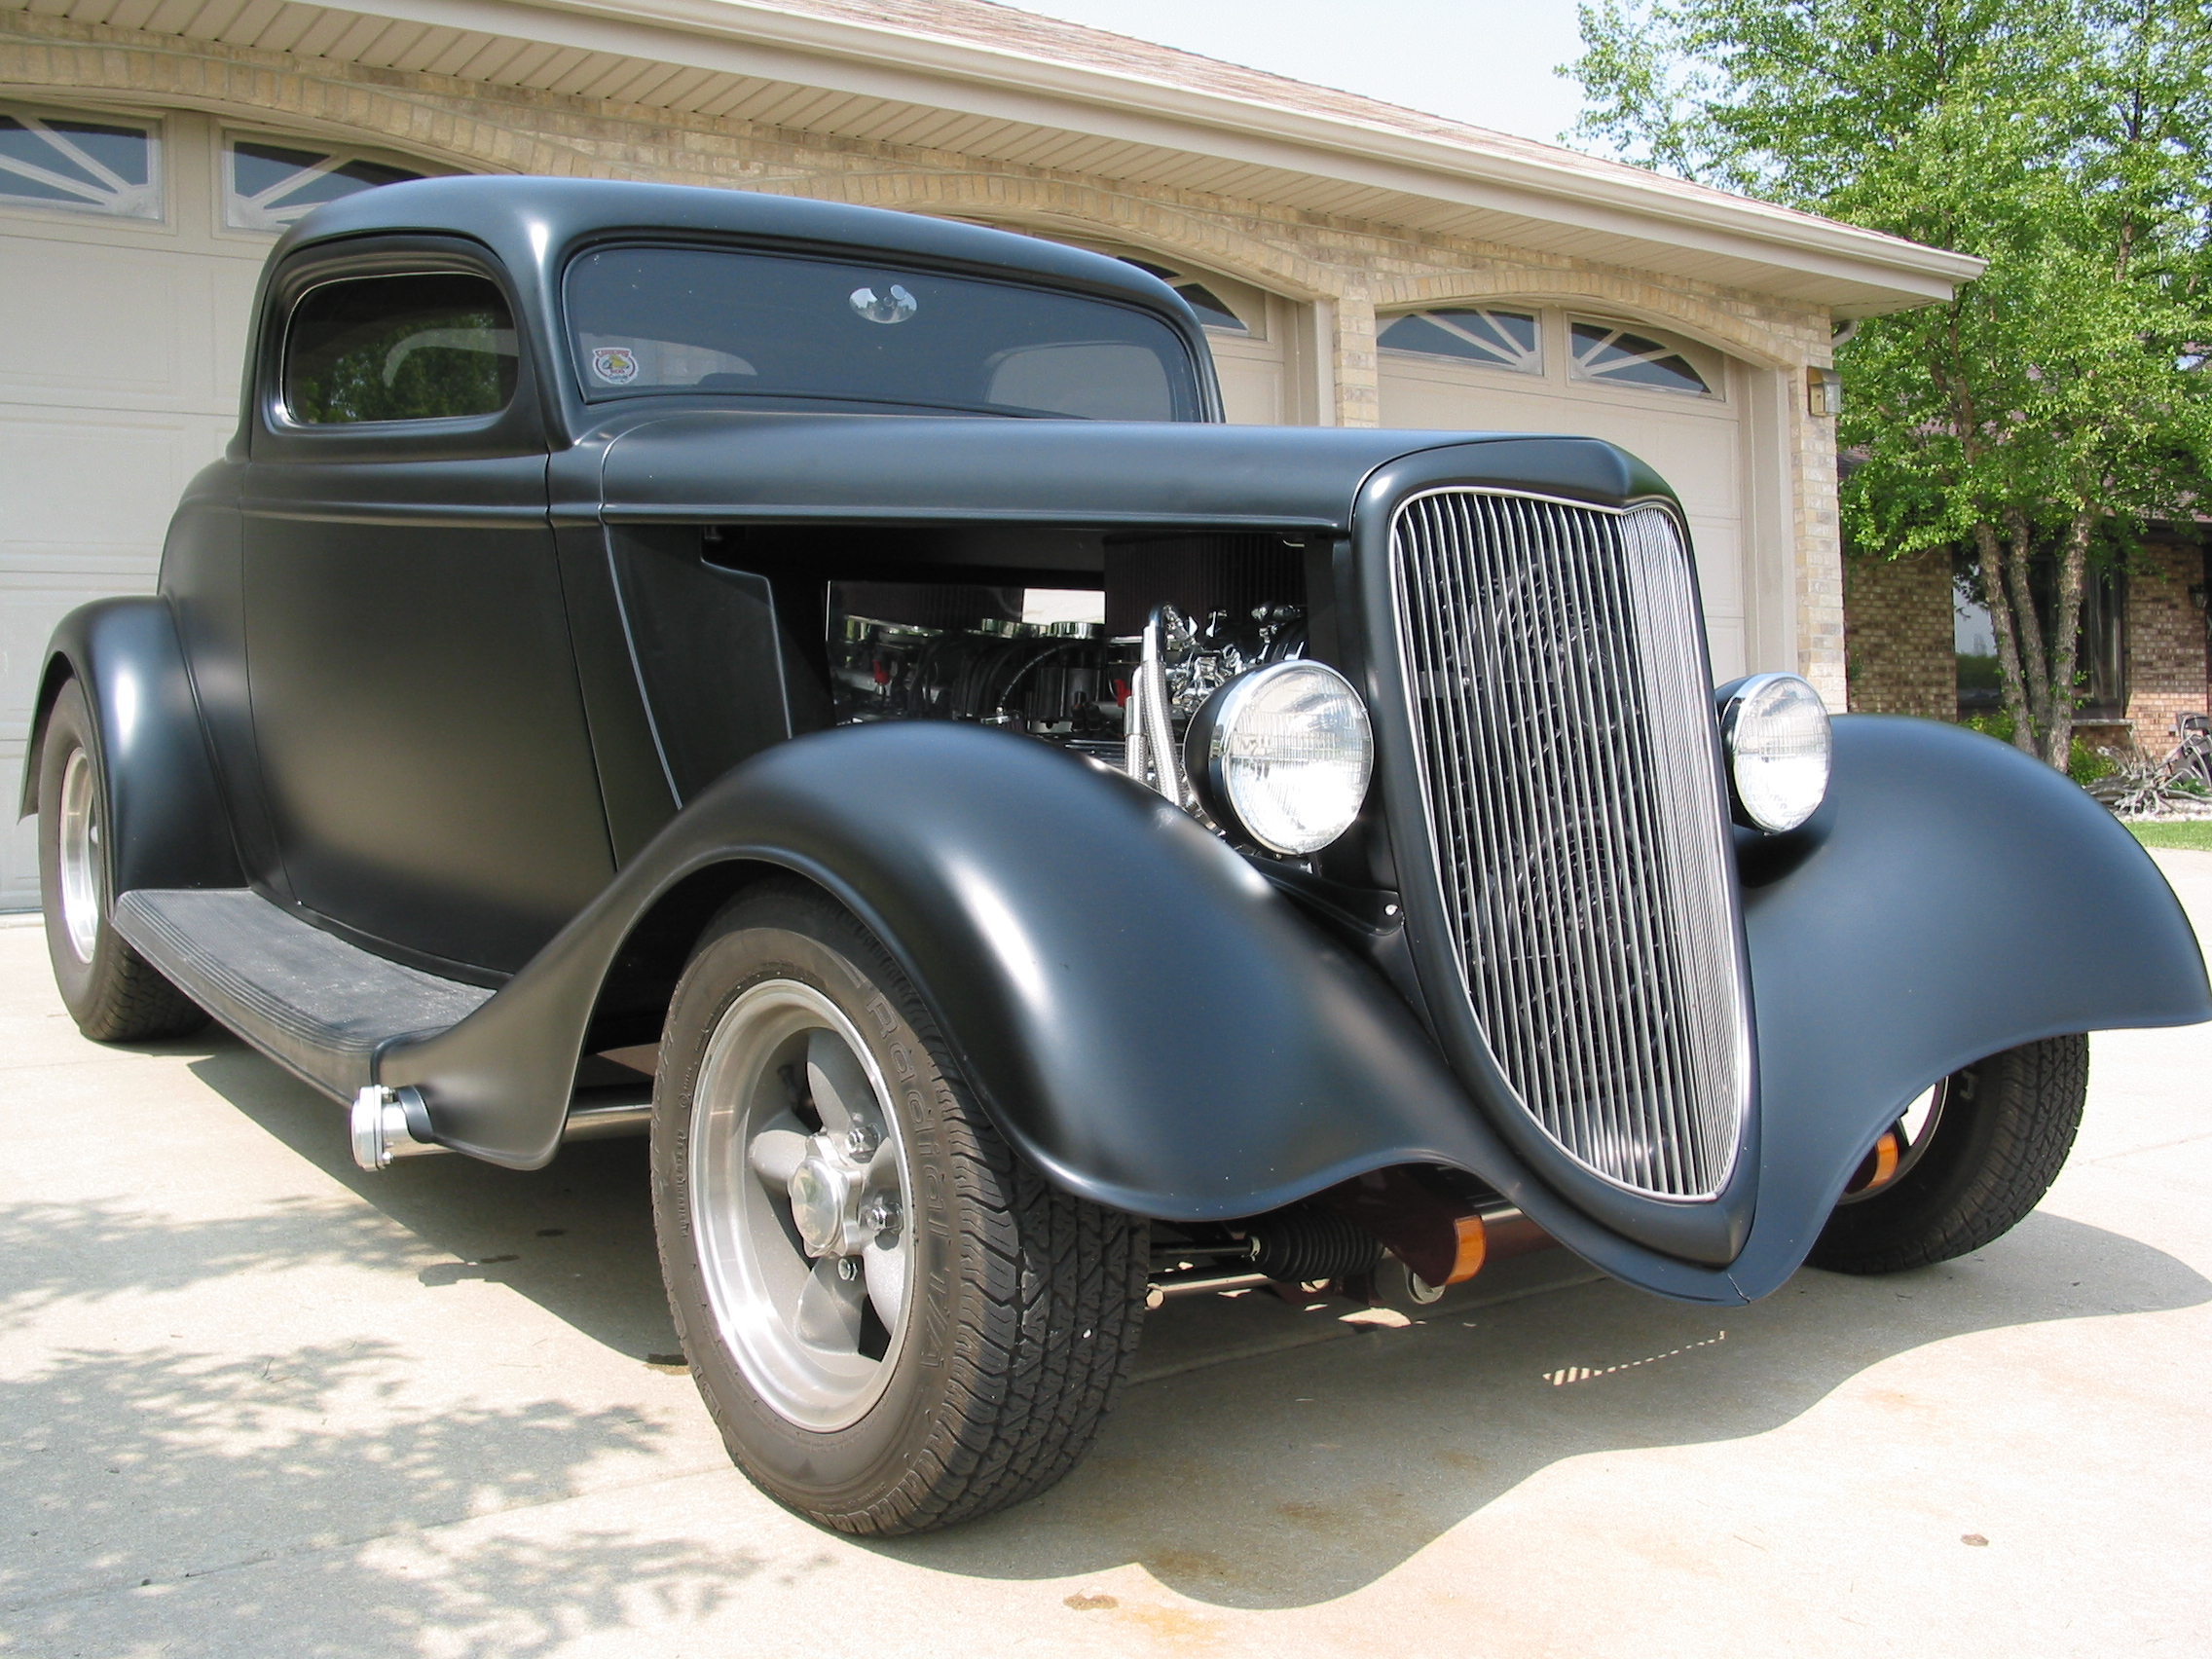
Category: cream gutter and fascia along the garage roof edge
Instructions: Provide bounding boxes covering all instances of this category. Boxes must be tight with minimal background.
[107,0,1982,316]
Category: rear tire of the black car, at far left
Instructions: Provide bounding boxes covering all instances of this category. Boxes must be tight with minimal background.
[38,680,208,1042]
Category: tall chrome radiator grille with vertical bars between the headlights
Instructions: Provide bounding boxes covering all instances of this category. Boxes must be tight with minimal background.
[1391,489,1750,1198]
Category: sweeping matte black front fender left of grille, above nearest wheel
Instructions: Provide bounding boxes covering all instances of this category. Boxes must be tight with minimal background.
[379,723,1503,1219]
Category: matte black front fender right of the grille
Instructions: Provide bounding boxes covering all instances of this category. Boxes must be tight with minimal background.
[1730,715,2212,1296]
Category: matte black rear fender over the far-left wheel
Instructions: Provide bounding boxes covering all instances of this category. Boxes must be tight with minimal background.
[19,595,245,894]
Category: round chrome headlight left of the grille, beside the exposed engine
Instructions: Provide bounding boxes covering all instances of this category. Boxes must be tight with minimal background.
[1184,661,1376,854]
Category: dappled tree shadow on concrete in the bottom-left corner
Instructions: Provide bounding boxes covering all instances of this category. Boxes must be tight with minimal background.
[0,1341,763,1659]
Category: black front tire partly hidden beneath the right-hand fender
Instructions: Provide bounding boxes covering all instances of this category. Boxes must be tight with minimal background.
[1807,1035,2088,1274]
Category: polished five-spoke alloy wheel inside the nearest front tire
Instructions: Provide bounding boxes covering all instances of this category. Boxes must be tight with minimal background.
[688,979,913,1431]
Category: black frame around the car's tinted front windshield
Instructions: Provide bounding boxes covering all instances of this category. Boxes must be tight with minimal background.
[555,230,1221,424]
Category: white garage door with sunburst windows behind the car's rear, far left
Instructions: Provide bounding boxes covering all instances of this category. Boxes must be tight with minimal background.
[0,104,426,909]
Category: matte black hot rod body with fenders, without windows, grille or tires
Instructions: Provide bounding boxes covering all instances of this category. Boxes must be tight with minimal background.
[24,179,2212,1303]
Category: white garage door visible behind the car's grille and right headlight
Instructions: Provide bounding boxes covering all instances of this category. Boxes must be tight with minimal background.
[1376,306,1746,680]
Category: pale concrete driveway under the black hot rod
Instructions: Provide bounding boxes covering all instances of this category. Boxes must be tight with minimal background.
[0,854,2212,1659]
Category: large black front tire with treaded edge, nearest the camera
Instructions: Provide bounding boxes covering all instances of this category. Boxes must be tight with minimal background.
[652,878,1150,1535]
